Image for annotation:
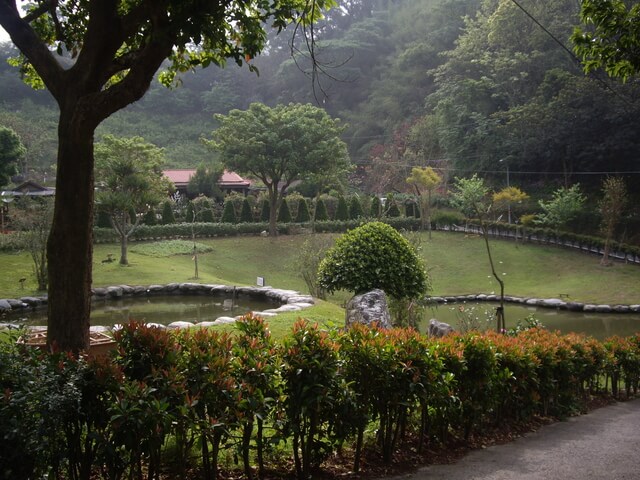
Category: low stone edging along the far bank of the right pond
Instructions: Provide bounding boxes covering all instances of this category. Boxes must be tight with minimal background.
[429,293,640,313]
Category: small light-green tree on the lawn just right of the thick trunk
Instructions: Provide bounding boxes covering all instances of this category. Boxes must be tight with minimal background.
[95,135,173,265]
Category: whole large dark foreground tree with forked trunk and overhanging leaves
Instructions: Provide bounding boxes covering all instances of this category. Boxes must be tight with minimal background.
[0,0,333,351]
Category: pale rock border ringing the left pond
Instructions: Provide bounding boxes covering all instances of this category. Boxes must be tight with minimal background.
[0,282,315,331]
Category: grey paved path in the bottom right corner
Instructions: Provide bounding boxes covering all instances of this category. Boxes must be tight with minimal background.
[388,399,640,480]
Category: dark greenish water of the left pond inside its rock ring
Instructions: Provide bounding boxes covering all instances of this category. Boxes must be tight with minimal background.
[0,295,280,326]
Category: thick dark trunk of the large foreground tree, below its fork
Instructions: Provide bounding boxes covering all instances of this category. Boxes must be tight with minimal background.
[47,107,95,352]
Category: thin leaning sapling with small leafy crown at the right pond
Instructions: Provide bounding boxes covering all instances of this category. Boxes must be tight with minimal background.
[452,174,506,333]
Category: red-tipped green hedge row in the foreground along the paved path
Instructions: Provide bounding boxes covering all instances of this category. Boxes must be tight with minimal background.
[0,316,640,480]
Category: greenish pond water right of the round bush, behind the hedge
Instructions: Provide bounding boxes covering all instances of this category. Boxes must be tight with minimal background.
[420,302,640,340]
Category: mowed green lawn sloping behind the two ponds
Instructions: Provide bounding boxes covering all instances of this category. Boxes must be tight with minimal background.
[0,232,640,304]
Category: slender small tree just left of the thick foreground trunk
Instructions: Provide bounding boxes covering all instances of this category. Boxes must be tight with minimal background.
[13,197,53,290]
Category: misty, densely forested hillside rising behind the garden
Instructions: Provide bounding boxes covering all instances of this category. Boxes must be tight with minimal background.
[0,0,640,201]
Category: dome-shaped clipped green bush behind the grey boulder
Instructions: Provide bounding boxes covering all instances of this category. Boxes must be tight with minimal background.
[318,222,429,299]
